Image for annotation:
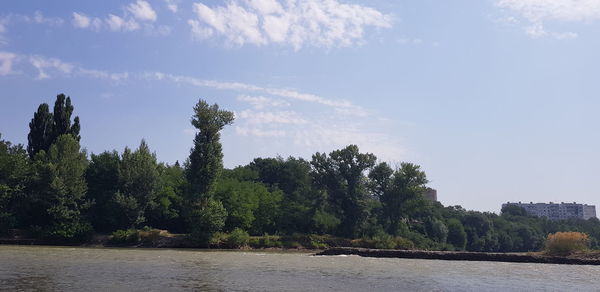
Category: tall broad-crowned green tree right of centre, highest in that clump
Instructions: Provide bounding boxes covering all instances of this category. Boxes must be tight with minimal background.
[311,145,377,237]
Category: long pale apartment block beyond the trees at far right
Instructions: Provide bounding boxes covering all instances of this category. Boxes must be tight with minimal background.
[502,202,596,220]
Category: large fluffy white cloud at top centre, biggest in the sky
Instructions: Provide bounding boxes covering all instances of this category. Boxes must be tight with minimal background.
[188,0,392,50]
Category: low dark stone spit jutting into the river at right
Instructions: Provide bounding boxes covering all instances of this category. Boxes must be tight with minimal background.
[316,247,600,265]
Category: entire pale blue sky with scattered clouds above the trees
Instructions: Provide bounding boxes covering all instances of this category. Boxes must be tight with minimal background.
[0,0,600,212]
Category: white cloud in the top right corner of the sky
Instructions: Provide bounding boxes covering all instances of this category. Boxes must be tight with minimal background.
[496,0,600,39]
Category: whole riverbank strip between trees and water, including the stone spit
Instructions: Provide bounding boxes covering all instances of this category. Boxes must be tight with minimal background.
[0,234,600,266]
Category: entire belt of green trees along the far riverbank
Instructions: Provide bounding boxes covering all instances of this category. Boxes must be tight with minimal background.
[0,94,600,251]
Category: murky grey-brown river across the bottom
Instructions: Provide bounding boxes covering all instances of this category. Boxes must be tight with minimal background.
[0,245,600,291]
